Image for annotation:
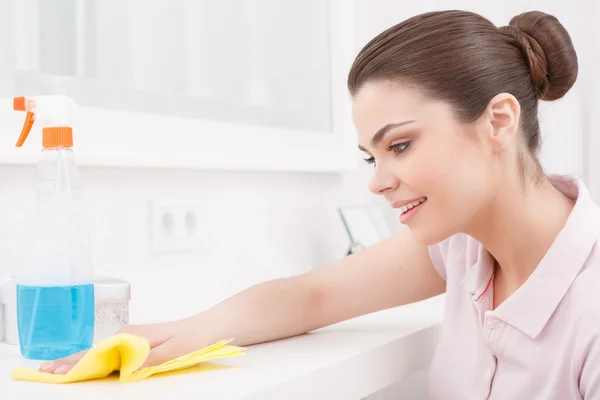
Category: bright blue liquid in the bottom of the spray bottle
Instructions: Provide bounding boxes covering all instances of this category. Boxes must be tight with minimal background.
[17,284,94,360]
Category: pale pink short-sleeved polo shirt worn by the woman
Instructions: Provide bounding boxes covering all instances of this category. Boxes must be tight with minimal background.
[429,177,600,400]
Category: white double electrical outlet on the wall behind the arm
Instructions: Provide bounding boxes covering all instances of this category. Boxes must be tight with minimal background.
[150,200,201,253]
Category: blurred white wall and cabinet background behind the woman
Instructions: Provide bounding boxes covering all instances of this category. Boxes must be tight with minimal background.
[0,0,600,323]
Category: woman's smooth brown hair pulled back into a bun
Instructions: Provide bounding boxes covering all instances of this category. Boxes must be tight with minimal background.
[348,11,578,162]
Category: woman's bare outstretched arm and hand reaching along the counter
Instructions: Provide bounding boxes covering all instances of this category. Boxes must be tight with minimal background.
[42,230,445,373]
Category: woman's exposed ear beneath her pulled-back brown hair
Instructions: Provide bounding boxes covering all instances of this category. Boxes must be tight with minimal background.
[485,93,521,152]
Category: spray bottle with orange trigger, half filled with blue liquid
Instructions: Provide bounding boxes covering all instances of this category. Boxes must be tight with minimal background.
[14,96,94,360]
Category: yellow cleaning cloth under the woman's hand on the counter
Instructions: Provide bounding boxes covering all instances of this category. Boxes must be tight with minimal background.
[12,333,245,383]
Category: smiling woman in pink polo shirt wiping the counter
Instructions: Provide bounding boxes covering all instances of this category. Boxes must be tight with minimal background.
[42,11,600,399]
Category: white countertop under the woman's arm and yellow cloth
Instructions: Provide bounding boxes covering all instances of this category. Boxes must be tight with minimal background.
[0,295,444,400]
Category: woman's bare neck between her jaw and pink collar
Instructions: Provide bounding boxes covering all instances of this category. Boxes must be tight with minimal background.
[467,177,574,297]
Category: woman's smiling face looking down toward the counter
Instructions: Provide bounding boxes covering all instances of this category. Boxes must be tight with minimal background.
[352,82,499,244]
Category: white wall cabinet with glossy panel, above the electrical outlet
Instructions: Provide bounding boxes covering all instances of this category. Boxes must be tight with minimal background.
[0,0,355,171]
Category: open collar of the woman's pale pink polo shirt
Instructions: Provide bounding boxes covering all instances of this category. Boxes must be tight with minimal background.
[464,177,600,339]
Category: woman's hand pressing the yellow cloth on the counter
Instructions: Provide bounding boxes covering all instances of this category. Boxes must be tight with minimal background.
[40,320,200,374]
